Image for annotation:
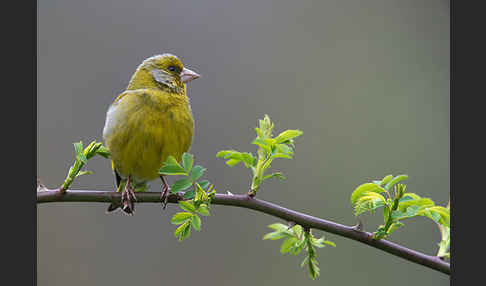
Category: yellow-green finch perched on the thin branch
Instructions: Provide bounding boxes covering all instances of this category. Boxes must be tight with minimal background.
[103,53,200,215]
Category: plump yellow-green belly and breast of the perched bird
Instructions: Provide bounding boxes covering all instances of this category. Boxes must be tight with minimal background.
[103,100,194,181]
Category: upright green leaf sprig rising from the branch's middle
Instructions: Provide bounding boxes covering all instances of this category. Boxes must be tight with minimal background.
[216,115,303,195]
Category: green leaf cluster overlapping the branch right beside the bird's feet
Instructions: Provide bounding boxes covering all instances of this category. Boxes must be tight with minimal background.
[159,153,216,241]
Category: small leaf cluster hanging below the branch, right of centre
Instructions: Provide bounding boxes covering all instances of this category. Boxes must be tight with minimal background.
[263,223,336,279]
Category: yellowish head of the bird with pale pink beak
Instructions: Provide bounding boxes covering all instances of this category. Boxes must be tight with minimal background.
[128,53,200,93]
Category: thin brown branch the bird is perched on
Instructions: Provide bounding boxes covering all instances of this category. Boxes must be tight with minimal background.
[37,190,451,275]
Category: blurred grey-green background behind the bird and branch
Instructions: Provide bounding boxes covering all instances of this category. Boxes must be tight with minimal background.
[37,0,450,286]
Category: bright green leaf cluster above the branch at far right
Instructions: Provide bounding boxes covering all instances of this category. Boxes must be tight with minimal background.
[351,175,450,239]
